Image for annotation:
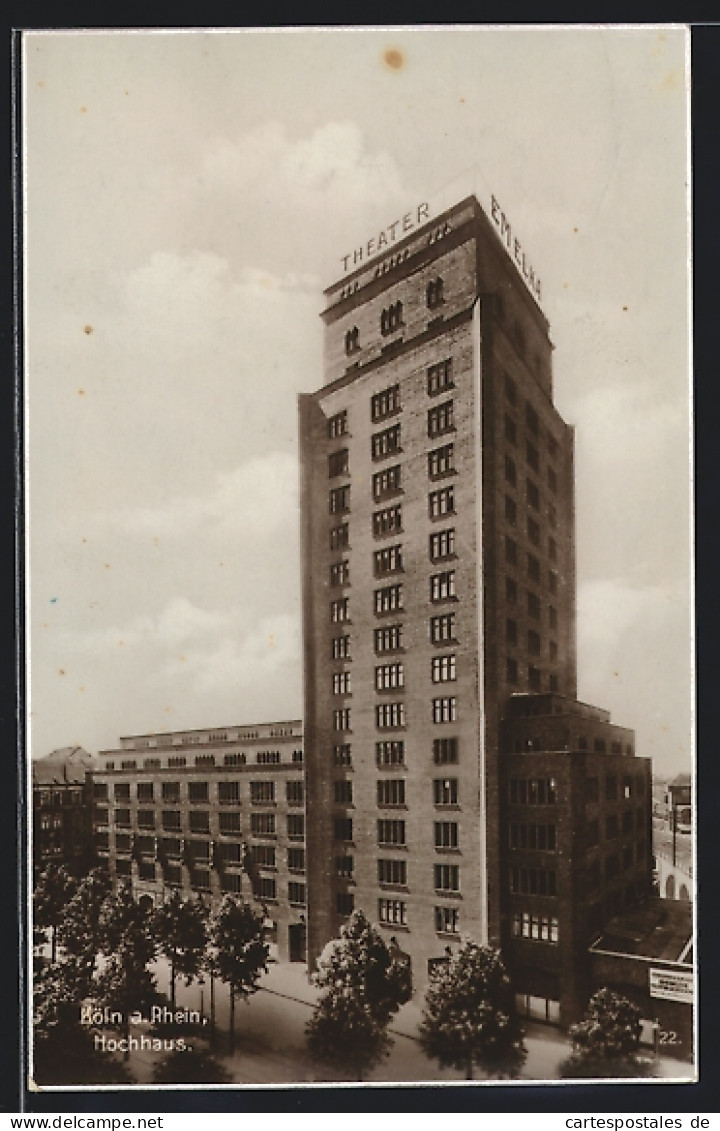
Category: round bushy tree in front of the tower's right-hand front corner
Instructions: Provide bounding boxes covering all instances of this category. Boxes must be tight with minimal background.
[419,939,527,1080]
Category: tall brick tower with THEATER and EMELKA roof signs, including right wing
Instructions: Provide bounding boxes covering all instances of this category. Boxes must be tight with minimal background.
[300,197,651,1019]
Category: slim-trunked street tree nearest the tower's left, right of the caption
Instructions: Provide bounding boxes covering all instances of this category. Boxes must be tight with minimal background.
[212,896,269,1054]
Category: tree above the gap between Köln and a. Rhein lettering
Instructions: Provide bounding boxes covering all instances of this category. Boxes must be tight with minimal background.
[96,883,157,1060]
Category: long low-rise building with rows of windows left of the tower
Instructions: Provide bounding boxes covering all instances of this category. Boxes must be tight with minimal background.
[93,720,306,961]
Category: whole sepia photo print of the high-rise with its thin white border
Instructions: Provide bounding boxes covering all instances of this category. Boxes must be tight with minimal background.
[19,24,702,1085]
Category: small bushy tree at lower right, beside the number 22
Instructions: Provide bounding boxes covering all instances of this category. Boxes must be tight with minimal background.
[559,988,648,1078]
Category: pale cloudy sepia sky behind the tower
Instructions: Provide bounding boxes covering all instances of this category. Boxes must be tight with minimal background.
[23,26,693,774]
